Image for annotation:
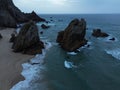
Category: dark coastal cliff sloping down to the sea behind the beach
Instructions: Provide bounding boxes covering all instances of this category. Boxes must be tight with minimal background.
[0,0,45,27]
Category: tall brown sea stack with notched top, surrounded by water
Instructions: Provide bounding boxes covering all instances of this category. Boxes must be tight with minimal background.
[57,19,87,51]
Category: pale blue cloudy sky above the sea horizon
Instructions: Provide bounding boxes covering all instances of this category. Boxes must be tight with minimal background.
[13,0,120,14]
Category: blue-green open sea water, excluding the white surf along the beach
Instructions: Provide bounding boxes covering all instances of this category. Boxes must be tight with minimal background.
[39,15,120,90]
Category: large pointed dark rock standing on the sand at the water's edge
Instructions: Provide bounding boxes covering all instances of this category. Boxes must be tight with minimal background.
[12,21,44,55]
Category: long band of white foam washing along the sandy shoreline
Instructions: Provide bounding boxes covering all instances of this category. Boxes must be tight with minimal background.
[10,42,52,90]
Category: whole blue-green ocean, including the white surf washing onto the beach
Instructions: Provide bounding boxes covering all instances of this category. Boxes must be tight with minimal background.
[11,14,120,90]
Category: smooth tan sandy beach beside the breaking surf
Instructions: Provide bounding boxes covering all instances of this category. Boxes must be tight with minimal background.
[0,28,33,90]
